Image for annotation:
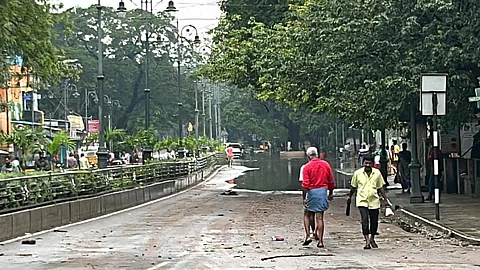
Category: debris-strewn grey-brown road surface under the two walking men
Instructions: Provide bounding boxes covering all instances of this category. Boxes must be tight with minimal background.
[0,166,480,270]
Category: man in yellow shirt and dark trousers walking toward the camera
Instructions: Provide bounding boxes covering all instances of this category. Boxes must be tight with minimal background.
[348,155,388,249]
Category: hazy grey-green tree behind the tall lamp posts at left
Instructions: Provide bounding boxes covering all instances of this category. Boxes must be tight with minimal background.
[55,6,200,135]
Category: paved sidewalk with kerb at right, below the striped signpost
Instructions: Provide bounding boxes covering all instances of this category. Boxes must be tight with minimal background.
[388,190,480,244]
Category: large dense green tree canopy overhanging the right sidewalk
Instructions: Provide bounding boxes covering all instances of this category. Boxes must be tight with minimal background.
[203,0,480,129]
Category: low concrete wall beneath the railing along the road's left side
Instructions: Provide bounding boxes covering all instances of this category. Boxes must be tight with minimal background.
[0,167,213,241]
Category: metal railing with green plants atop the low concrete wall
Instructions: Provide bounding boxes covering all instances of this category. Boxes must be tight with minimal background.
[0,154,217,212]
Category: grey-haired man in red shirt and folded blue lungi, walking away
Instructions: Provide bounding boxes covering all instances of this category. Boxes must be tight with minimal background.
[302,147,335,248]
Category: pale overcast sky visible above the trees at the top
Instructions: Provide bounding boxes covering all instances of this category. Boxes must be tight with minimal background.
[54,0,220,38]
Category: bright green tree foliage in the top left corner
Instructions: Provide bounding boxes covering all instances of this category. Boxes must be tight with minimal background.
[0,0,65,81]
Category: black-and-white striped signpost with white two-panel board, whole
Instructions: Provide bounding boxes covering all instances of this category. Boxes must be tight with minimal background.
[420,73,447,220]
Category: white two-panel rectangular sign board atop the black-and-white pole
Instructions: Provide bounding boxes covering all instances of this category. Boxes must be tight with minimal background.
[420,73,447,115]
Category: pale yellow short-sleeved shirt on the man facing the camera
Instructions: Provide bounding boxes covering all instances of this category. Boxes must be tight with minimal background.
[351,168,385,209]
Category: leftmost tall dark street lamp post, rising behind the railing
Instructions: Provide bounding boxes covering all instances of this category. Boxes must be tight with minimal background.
[97,0,108,169]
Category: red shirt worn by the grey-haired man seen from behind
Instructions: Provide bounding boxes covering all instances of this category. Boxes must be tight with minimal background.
[302,158,335,190]
